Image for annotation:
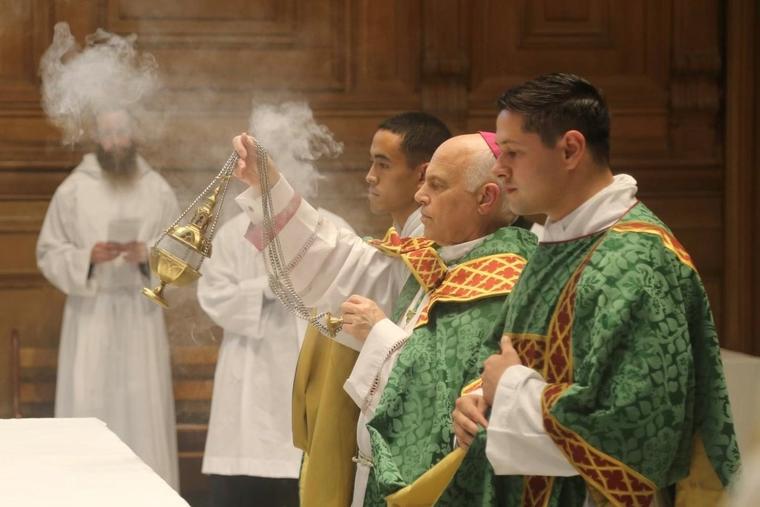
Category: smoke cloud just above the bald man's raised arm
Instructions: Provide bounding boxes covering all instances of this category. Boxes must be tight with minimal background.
[249,102,343,198]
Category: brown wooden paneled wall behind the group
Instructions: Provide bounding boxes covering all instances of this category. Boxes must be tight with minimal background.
[0,0,760,504]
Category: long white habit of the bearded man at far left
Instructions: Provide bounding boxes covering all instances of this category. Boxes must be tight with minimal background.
[37,154,179,489]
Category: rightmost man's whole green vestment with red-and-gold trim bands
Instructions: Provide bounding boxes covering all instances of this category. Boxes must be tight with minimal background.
[499,203,739,507]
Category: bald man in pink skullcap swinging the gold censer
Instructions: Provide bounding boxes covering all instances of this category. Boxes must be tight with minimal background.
[234,134,535,505]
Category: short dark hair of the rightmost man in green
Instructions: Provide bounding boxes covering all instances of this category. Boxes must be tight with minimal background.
[498,73,610,165]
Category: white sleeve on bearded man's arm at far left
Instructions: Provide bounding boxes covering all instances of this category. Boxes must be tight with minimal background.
[37,185,97,296]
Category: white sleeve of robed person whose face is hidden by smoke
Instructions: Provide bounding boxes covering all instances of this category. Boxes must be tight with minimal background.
[198,222,275,338]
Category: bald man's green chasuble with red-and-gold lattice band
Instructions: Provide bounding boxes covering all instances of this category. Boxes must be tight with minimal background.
[364,227,536,506]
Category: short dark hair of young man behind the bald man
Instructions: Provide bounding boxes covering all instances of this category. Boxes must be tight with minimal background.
[377,111,451,167]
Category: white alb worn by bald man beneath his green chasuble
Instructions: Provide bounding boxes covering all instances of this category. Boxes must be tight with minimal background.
[237,178,490,506]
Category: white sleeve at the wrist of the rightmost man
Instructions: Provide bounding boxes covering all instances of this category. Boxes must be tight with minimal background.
[486,365,578,477]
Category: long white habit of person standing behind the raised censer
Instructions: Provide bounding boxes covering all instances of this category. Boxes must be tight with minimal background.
[198,210,351,478]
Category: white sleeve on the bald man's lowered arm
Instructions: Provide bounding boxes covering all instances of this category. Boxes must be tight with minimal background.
[343,318,408,410]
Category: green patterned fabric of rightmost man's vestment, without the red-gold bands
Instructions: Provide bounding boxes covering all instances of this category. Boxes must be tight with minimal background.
[501,203,740,507]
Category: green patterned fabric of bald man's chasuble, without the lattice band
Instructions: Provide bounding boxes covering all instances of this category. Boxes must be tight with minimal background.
[364,227,536,506]
